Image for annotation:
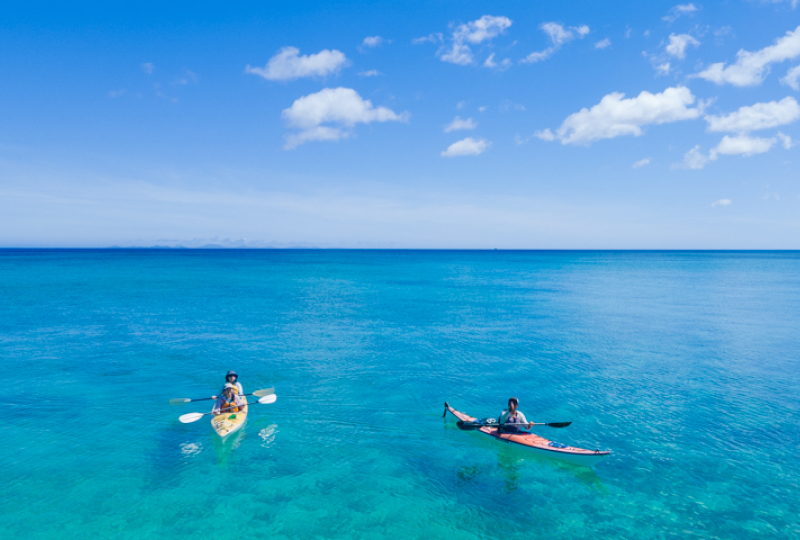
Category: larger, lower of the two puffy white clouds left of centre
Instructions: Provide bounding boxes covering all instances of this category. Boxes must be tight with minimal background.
[281,88,408,150]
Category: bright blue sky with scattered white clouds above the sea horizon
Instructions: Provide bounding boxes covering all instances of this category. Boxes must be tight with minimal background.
[0,0,800,249]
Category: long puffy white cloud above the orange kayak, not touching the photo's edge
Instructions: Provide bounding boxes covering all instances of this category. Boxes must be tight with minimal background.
[537,86,702,145]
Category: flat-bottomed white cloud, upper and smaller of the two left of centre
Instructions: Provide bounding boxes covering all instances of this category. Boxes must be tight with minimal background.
[245,47,348,81]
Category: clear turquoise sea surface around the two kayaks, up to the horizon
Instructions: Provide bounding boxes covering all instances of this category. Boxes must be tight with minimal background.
[0,250,800,540]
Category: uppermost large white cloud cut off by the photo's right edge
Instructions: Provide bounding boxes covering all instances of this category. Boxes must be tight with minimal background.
[694,26,800,86]
